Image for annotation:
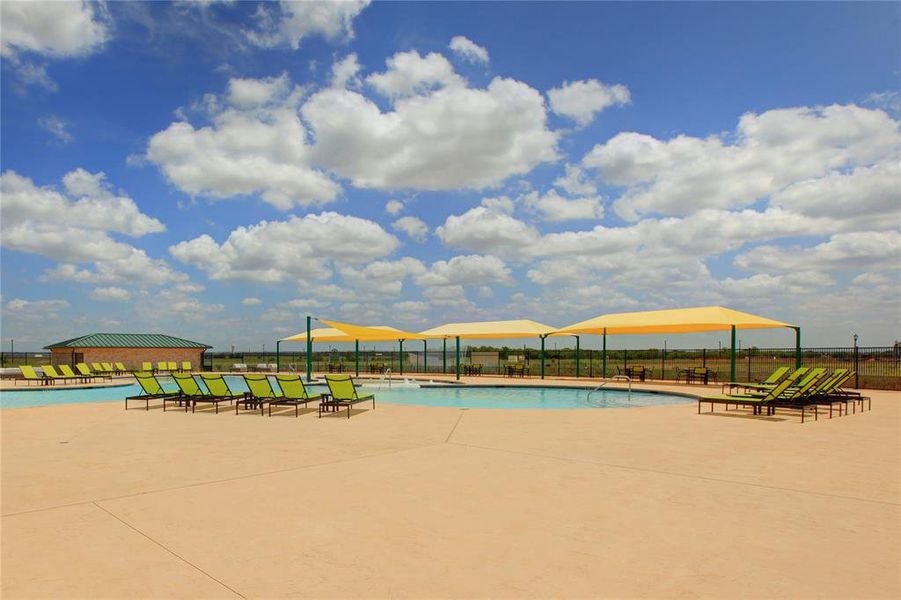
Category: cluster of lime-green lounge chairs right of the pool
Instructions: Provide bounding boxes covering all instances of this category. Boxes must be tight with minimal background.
[698,367,871,423]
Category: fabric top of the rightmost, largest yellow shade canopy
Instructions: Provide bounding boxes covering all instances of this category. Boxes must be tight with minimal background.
[558,306,794,335]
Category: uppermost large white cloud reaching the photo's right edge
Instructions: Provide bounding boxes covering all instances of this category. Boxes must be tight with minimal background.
[582,105,901,220]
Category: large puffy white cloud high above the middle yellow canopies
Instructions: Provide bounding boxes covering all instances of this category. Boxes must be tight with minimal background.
[301,78,558,190]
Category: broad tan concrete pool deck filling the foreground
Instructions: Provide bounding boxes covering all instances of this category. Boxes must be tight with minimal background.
[0,377,901,598]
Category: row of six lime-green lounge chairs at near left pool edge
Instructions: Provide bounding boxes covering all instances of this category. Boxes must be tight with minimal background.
[125,373,375,419]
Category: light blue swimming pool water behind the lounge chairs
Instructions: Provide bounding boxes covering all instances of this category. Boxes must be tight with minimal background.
[0,376,693,409]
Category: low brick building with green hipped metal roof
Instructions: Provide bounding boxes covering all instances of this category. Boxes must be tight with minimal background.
[44,333,212,370]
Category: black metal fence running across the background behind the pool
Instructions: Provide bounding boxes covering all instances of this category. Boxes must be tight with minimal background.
[0,346,901,390]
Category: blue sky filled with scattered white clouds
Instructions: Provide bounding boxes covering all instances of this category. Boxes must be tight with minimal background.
[0,1,901,348]
